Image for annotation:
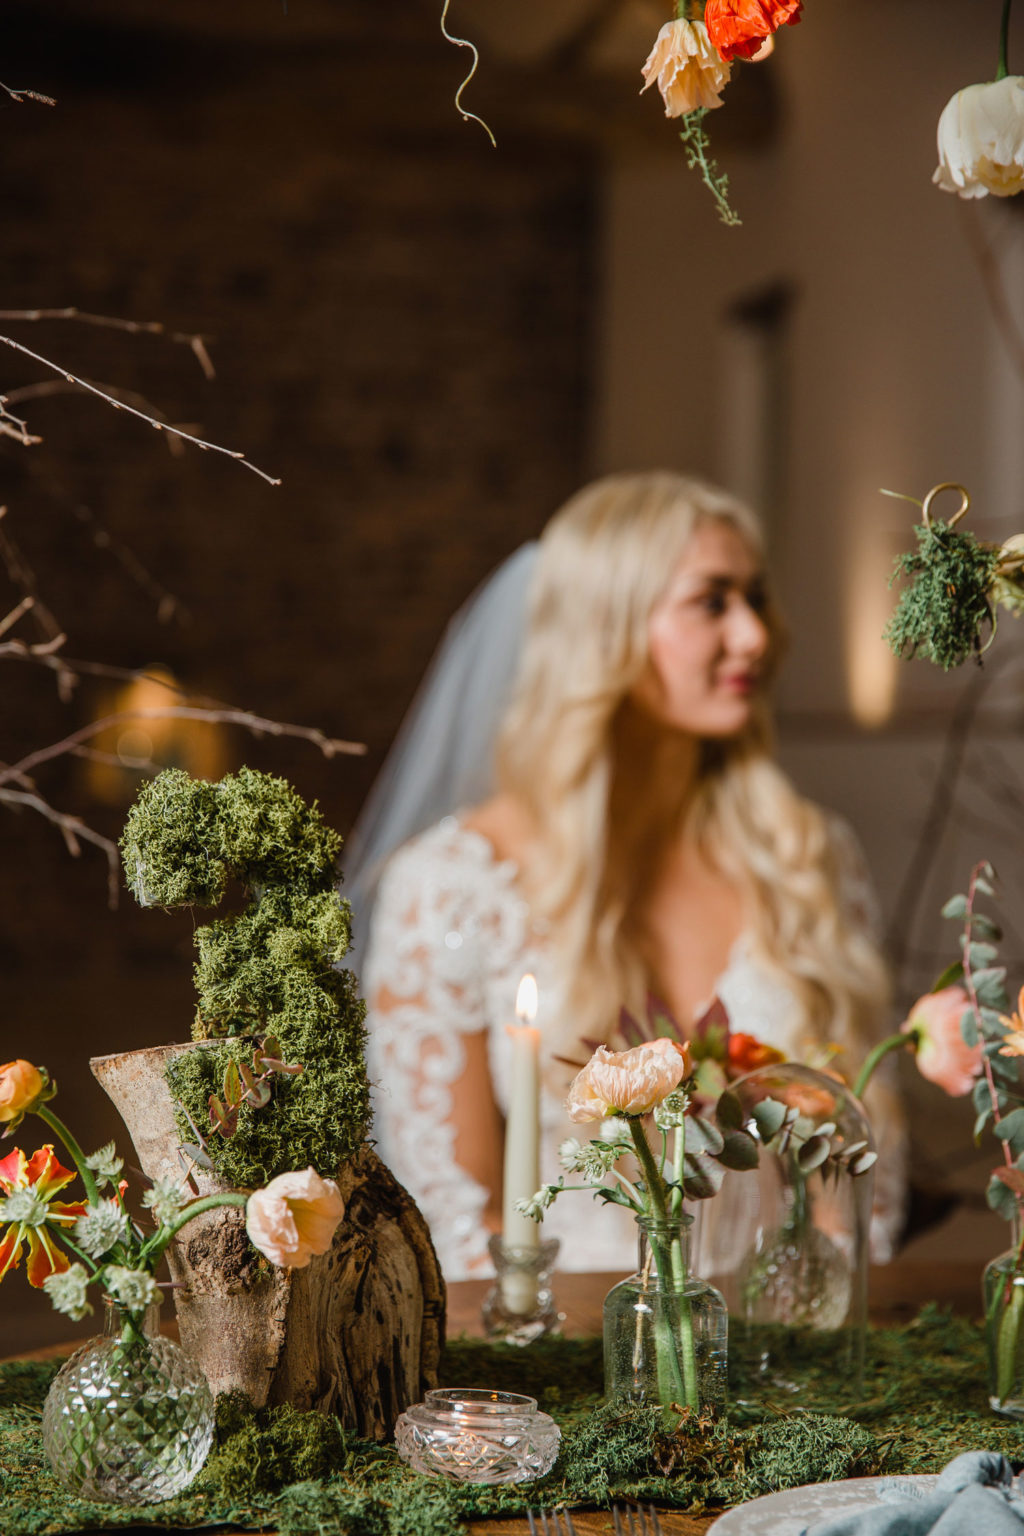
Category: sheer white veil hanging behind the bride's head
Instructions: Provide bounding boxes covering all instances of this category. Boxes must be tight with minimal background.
[342,542,537,966]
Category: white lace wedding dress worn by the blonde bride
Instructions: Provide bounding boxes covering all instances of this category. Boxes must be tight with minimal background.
[362,816,901,1279]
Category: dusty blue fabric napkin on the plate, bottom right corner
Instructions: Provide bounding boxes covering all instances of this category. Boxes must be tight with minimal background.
[804,1450,1024,1536]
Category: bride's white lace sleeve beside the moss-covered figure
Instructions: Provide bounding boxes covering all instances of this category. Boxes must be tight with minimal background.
[364,833,503,1279]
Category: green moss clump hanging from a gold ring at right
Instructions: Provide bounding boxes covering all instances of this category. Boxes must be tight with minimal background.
[884,519,999,671]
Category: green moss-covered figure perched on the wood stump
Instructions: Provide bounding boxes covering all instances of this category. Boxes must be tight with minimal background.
[121,768,370,1186]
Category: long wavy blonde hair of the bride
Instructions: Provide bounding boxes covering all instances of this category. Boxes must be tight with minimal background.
[496,472,887,1081]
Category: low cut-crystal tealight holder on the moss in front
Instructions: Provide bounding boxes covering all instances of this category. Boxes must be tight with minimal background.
[395,1387,562,1482]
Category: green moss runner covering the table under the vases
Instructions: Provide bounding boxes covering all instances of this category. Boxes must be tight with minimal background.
[0,1306,1024,1536]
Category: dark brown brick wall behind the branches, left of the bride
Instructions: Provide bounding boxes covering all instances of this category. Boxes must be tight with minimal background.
[0,3,594,1353]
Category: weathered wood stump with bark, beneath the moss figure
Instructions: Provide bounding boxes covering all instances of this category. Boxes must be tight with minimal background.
[89,1043,445,1439]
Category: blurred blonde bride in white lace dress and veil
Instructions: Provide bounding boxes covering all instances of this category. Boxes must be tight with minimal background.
[347,473,903,1279]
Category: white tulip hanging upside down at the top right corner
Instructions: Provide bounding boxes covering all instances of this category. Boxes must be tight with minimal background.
[932,75,1024,197]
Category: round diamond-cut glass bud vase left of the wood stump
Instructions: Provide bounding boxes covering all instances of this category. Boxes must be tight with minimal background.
[43,1301,213,1504]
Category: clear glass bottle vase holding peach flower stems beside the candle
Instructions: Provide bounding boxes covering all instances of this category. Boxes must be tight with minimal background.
[605,1215,729,1410]
